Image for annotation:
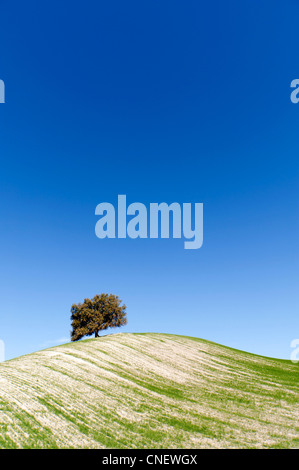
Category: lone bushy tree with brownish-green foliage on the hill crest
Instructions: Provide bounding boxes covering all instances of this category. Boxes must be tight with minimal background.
[71,294,127,341]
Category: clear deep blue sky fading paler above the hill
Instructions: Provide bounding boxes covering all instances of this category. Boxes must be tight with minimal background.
[0,0,299,358]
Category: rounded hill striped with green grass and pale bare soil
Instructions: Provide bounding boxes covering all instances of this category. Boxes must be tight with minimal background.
[0,333,299,448]
